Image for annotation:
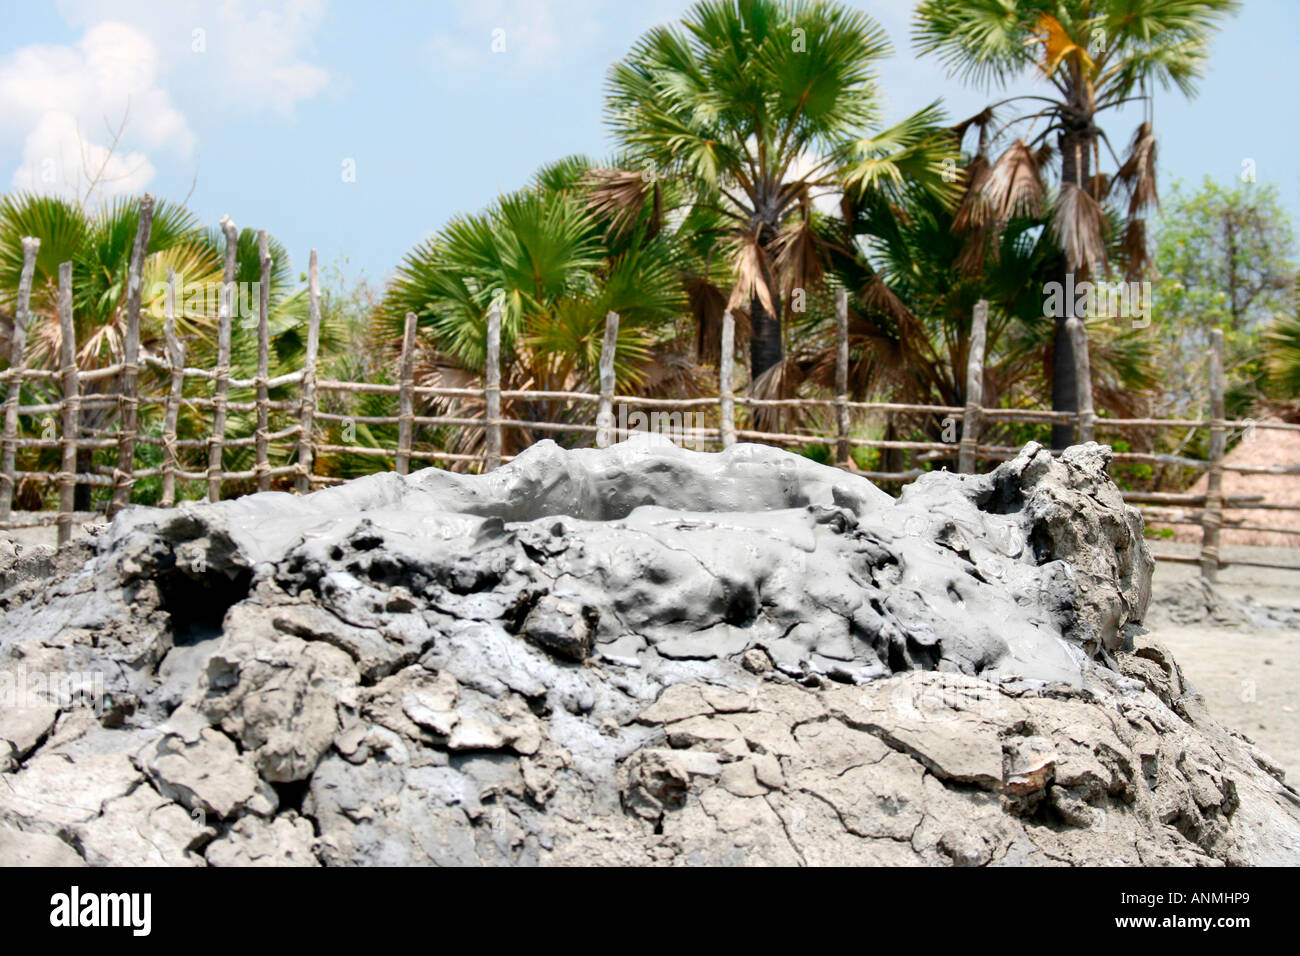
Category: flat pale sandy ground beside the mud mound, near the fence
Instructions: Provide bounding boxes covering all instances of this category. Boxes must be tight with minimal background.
[0,527,1300,786]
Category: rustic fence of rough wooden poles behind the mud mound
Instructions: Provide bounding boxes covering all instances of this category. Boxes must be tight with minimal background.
[0,213,1300,579]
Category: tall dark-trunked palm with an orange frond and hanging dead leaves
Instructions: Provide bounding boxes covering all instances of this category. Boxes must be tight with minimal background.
[915,0,1239,447]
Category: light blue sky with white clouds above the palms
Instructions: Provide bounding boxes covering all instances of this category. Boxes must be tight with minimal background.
[0,0,1300,287]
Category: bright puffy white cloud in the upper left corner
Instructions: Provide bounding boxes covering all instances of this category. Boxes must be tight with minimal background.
[0,0,330,199]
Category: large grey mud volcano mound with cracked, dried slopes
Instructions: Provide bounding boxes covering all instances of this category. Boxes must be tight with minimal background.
[0,442,1300,865]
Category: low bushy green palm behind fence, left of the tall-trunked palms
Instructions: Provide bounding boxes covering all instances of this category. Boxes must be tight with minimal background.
[376,157,688,468]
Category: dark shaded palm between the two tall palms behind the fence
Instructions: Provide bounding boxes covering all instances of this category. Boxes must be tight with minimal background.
[815,180,1153,412]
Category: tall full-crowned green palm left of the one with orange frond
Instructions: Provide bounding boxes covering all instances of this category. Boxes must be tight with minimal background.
[605,0,956,380]
